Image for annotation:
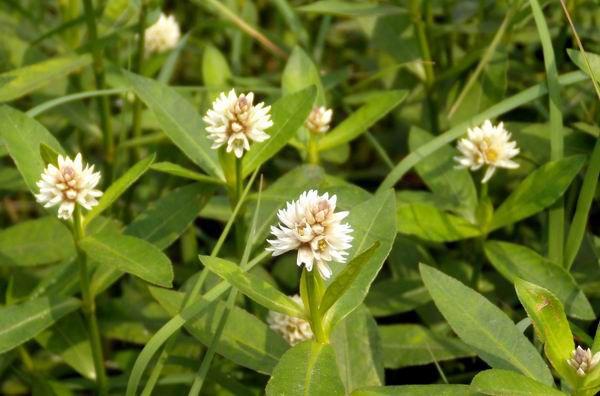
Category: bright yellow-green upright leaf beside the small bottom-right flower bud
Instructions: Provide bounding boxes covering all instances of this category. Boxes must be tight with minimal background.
[515,279,578,385]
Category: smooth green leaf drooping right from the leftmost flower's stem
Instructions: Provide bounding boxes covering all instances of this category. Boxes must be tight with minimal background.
[80,233,173,287]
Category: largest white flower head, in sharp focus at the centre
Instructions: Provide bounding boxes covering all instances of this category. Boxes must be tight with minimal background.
[267,190,353,279]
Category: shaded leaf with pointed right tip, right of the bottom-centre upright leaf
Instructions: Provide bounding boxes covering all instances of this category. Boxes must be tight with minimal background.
[379,324,475,369]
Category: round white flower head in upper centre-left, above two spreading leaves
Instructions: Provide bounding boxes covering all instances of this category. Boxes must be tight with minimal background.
[203,89,273,158]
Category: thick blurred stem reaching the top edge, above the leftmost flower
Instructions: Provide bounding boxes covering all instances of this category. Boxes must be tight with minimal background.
[83,0,115,184]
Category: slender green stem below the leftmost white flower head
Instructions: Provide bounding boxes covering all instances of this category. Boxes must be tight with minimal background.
[73,206,108,395]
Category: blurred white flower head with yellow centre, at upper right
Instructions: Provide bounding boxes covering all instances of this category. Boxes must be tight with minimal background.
[454,120,519,183]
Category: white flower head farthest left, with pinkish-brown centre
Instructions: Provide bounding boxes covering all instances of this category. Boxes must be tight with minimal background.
[35,154,102,220]
